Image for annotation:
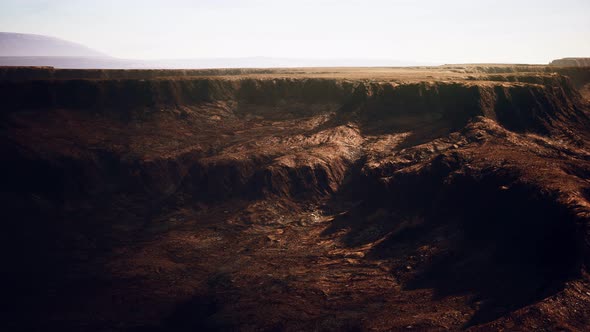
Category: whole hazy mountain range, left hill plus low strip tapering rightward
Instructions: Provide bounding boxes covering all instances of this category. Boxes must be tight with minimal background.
[0,32,438,69]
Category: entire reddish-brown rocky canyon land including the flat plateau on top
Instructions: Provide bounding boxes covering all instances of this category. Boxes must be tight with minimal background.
[0,65,590,331]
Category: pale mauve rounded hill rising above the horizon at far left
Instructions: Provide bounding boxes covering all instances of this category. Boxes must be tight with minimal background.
[0,32,108,57]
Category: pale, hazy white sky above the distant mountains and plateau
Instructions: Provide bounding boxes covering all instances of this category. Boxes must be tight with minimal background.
[0,0,590,63]
